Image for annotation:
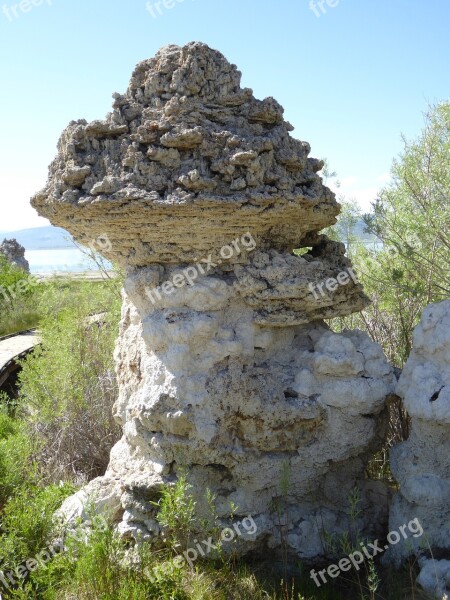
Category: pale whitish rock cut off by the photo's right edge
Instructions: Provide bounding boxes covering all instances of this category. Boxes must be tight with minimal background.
[390,300,450,562]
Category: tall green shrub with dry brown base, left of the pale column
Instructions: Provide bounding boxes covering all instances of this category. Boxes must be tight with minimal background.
[19,281,120,482]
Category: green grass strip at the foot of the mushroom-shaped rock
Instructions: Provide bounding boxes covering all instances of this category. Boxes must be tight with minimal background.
[3,516,425,600]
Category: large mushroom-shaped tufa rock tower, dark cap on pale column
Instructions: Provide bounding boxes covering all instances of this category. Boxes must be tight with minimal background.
[32,43,395,558]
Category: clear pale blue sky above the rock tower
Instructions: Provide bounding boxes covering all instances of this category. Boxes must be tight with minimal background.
[0,0,450,230]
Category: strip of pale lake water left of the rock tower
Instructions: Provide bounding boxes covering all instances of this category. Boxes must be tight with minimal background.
[25,248,103,274]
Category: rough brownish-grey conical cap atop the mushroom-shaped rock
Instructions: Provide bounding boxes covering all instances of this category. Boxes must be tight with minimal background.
[32,43,339,267]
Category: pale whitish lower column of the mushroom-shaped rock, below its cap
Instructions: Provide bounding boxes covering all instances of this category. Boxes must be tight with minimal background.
[56,269,394,558]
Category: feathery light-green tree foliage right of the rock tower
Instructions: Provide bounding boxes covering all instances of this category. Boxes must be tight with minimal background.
[333,102,450,367]
